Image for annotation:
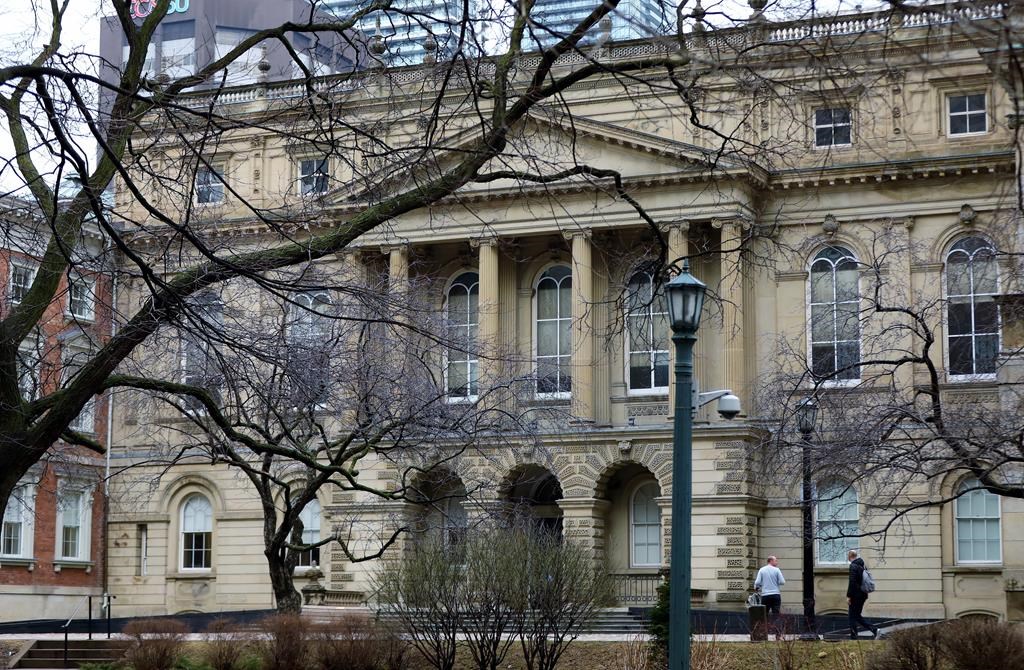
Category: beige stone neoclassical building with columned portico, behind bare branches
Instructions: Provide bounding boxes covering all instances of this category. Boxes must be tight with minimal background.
[83,3,1024,621]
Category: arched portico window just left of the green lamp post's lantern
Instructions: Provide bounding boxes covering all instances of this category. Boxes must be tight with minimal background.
[626,270,669,391]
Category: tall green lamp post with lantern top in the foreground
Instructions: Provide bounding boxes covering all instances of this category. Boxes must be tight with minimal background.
[665,261,708,670]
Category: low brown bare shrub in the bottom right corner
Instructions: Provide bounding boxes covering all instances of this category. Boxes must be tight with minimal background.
[941,619,1024,670]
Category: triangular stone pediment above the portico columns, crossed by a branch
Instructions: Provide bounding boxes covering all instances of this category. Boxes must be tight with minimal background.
[327,109,745,205]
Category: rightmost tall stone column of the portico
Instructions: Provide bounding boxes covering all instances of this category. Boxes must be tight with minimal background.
[713,217,750,412]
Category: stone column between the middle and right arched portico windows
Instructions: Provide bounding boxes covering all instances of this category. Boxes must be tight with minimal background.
[565,229,594,423]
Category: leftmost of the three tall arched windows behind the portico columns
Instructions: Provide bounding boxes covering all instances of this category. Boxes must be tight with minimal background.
[444,273,480,400]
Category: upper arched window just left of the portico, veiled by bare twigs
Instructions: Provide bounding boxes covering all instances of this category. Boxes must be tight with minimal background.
[287,291,333,408]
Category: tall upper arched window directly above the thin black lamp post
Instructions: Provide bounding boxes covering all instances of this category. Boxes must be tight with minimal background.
[809,247,860,380]
